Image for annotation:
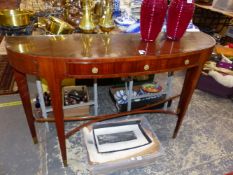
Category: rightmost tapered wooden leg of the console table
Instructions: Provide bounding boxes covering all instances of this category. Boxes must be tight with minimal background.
[173,67,201,138]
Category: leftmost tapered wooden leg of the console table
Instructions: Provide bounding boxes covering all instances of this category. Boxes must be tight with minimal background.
[14,70,38,144]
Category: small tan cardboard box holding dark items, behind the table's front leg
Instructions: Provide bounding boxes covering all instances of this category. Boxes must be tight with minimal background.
[62,86,90,117]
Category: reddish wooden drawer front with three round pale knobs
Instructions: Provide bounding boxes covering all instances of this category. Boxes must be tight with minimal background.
[66,55,199,76]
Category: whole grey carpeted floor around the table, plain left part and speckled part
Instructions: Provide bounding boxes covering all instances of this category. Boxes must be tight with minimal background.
[0,74,233,175]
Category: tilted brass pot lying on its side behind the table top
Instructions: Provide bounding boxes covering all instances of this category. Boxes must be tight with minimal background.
[46,16,75,35]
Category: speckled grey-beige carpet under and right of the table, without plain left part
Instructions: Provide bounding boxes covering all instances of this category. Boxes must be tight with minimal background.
[35,75,233,175]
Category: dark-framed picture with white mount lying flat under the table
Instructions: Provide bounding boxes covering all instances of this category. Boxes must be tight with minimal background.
[93,120,151,153]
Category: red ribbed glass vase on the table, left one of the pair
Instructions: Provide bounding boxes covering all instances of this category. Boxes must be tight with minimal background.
[140,0,167,42]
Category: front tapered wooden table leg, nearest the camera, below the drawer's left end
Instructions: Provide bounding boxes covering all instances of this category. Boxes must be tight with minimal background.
[47,78,67,166]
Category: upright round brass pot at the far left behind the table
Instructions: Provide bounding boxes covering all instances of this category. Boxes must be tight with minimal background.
[0,9,33,27]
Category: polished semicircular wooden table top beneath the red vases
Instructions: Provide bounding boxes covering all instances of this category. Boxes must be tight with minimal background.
[6,32,215,61]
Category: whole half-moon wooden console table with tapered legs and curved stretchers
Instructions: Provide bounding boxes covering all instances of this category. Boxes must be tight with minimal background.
[6,32,215,166]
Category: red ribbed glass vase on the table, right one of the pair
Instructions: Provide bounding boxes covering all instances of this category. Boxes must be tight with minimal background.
[167,0,194,40]
